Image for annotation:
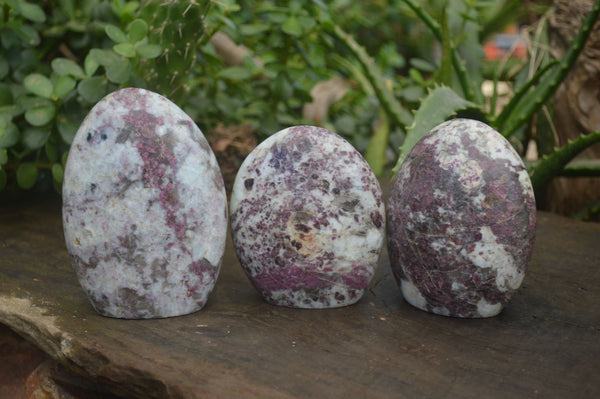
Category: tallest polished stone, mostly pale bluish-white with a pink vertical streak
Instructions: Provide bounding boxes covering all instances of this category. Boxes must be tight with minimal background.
[63,88,227,319]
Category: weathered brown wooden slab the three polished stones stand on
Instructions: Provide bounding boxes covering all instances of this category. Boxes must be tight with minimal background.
[0,199,600,398]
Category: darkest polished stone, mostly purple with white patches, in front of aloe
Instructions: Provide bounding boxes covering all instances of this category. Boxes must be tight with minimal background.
[388,119,536,318]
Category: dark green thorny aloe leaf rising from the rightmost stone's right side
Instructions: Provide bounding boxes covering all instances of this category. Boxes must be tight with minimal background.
[529,131,600,195]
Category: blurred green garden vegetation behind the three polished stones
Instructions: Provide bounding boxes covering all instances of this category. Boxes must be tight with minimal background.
[0,0,600,219]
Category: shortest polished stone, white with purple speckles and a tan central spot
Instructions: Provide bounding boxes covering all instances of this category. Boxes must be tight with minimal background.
[230,126,385,308]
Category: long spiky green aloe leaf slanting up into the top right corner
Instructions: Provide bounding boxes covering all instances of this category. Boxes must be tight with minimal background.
[500,0,600,137]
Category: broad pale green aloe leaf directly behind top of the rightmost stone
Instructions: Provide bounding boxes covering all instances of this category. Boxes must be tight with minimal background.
[393,86,477,175]
